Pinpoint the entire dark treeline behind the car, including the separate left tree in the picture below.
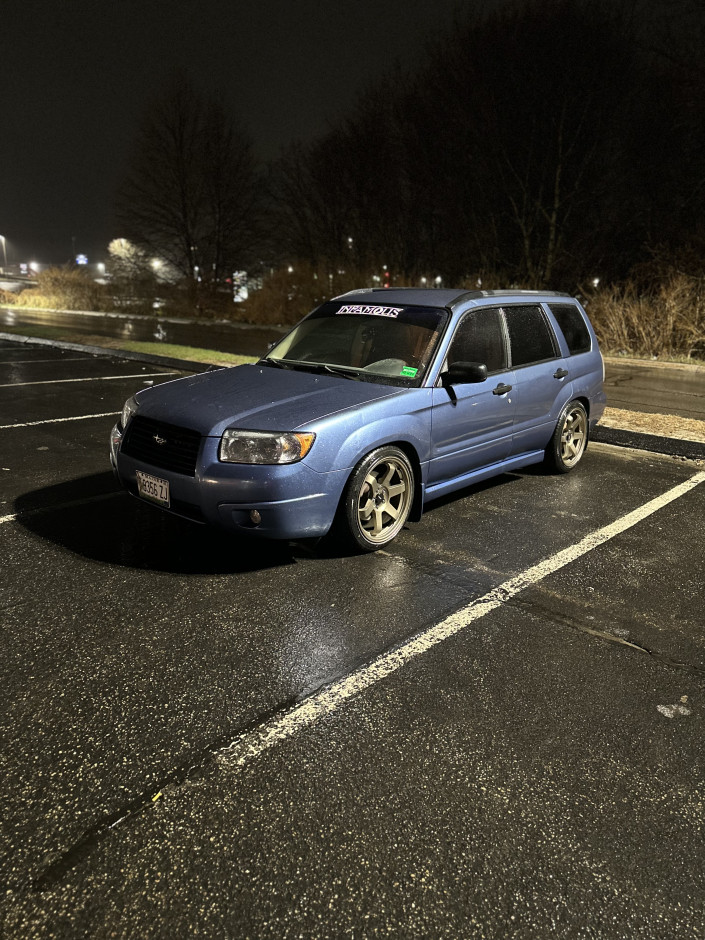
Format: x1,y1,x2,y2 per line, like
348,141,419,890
119,0,705,300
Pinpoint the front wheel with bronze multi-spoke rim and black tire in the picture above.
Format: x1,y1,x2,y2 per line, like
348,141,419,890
339,447,415,552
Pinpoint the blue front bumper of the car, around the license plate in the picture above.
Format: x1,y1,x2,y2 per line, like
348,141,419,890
110,425,347,539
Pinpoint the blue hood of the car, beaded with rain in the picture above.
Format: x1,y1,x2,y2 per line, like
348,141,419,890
137,365,403,437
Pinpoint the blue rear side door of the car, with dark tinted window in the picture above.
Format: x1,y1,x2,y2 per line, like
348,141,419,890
502,304,571,456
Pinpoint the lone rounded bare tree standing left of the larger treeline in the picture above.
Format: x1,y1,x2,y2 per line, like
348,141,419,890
117,77,257,287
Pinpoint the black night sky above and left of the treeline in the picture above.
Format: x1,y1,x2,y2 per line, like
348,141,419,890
0,0,486,263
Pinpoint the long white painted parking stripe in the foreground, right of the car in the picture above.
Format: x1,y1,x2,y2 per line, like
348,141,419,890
217,472,705,767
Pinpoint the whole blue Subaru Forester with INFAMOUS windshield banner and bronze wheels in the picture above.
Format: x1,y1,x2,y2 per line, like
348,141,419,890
110,288,605,551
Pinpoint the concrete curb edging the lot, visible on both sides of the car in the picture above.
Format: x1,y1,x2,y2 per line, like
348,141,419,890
0,333,705,460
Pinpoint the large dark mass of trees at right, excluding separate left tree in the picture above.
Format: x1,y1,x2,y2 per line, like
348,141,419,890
264,0,705,289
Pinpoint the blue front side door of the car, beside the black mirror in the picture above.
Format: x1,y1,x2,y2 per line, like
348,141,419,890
428,308,515,486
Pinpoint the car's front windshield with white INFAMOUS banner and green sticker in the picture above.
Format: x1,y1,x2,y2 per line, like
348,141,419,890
262,301,448,386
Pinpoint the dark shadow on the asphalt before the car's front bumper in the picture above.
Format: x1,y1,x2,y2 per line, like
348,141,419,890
14,471,297,575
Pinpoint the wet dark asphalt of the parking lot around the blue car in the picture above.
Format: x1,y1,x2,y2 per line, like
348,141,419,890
0,342,705,940
